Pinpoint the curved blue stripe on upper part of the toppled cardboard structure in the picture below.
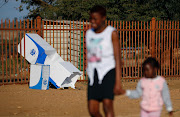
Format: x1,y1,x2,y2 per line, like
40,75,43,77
26,34,47,64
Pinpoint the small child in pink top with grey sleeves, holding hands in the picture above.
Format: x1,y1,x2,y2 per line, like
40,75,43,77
126,57,173,117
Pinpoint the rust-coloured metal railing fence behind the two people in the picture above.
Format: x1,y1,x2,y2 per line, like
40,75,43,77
0,17,180,85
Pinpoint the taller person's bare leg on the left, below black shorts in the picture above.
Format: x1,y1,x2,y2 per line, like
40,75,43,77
88,100,102,117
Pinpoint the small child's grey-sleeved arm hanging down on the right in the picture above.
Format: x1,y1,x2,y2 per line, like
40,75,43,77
162,81,173,113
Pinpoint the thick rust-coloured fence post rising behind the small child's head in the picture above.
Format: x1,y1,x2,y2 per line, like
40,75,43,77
151,17,156,57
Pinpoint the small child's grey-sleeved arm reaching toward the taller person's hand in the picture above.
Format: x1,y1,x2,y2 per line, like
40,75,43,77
126,80,142,99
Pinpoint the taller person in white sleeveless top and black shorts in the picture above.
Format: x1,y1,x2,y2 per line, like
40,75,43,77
86,6,123,117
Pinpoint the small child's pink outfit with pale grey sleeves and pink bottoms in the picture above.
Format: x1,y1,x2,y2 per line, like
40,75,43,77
126,76,172,117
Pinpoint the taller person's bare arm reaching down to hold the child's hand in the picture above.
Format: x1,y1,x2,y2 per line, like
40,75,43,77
112,31,125,95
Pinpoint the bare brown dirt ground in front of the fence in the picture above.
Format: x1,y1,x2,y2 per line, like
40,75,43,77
0,80,180,117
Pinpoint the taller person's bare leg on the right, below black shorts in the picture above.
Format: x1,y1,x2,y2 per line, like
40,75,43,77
103,99,114,117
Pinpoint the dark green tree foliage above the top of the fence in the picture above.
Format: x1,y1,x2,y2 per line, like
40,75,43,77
16,0,180,21
